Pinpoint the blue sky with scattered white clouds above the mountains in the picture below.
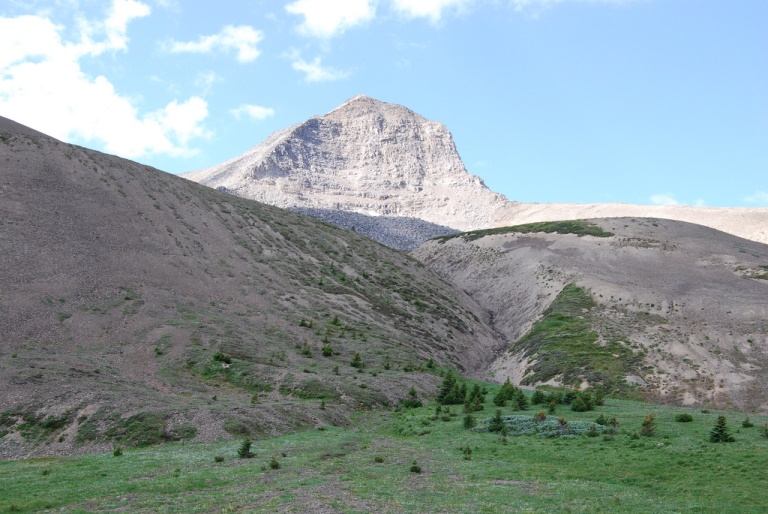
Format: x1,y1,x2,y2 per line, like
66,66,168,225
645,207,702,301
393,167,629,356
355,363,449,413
0,0,768,207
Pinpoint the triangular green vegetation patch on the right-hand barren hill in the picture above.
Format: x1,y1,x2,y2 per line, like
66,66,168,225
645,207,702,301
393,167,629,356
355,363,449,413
510,284,642,397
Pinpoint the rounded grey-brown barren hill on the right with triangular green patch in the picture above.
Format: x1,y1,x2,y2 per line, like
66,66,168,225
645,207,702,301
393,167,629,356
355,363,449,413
413,218,768,409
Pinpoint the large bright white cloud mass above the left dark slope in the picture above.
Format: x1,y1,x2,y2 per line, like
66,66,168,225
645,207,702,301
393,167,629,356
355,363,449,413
0,0,208,158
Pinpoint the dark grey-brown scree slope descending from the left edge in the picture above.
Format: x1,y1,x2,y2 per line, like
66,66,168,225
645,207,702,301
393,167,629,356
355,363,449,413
0,118,495,458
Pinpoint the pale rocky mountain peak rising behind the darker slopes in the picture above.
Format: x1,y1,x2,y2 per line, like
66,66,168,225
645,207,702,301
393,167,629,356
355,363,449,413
184,95,508,230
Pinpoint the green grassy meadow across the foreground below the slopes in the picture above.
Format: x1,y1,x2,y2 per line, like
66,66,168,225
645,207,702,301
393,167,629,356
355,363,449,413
0,385,768,513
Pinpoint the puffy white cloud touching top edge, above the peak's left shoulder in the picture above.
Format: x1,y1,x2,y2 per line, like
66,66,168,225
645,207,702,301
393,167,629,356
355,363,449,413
285,0,377,38
